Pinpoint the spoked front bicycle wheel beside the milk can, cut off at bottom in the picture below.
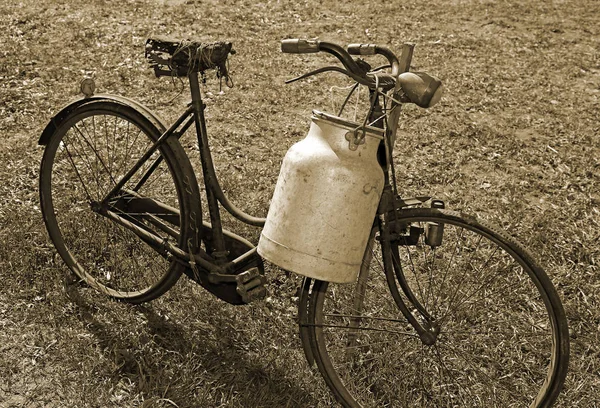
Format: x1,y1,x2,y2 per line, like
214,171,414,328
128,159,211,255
308,209,569,407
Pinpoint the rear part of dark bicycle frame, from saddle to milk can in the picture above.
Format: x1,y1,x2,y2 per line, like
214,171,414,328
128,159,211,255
93,73,265,283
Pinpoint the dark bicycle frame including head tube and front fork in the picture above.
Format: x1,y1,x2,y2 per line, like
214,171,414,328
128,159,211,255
86,44,440,332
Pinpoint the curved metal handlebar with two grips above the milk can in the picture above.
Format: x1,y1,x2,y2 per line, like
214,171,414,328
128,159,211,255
281,38,400,87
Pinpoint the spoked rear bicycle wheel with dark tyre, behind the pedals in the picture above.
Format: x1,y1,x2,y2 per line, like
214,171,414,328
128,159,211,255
40,100,201,303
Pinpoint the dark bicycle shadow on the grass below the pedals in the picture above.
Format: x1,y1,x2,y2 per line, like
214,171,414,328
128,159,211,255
68,284,318,408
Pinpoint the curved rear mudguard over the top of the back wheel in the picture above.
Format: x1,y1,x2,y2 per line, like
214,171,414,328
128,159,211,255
38,94,166,146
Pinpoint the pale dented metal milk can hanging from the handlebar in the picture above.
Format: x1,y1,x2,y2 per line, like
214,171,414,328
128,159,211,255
257,111,384,283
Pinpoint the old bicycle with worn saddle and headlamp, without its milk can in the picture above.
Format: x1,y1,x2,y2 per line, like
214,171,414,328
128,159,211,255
39,38,569,407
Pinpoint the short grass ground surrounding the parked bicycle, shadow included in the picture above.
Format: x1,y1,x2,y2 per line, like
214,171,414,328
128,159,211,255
0,0,600,407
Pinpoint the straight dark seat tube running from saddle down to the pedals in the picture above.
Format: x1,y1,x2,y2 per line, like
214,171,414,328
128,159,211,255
188,72,227,264
